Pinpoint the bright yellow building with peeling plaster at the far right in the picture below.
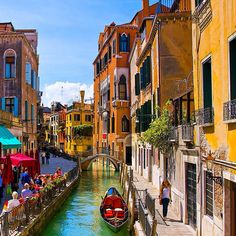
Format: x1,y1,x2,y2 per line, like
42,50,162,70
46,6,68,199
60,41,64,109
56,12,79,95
192,0,236,236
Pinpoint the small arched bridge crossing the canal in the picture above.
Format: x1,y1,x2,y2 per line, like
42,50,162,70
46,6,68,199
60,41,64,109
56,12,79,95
81,153,121,171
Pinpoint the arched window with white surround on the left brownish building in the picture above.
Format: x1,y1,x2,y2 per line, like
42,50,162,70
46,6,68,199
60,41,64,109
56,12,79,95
4,49,16,79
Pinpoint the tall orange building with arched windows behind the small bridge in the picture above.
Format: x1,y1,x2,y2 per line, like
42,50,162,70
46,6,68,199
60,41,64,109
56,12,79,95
93,0,157,164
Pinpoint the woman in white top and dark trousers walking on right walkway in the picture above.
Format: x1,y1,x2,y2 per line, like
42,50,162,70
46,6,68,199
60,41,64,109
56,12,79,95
159,179,171,220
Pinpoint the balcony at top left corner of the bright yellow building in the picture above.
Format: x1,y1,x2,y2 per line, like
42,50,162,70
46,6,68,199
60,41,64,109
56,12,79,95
192,0,212,32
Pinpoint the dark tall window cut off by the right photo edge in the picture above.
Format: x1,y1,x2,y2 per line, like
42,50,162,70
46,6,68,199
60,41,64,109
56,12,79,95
229,38,236,101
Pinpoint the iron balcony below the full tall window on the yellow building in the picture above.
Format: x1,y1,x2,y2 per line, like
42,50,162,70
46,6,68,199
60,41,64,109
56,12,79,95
195,107,214,126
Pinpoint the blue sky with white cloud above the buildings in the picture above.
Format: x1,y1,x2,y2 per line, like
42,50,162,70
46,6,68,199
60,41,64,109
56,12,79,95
0,0,157,106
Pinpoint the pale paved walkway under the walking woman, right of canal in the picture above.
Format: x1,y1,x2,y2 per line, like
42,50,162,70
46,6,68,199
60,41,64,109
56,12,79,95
134,172,195,236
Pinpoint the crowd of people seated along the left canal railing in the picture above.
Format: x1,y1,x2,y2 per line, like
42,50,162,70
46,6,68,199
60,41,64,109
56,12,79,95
0,167,63,212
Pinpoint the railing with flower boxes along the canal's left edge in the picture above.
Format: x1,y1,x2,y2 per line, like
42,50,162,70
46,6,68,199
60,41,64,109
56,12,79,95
0,167,78,236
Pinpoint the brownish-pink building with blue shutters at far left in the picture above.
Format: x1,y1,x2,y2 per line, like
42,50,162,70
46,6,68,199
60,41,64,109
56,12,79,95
0,23,41,152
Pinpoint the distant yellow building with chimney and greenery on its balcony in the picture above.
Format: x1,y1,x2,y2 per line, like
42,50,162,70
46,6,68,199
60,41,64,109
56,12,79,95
65,91,93,156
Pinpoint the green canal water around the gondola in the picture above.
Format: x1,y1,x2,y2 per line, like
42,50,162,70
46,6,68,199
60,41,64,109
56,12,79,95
41,162,130,236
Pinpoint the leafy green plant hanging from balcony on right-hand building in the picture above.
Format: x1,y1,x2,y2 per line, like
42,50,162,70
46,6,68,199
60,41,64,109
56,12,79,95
141,103,172,154
